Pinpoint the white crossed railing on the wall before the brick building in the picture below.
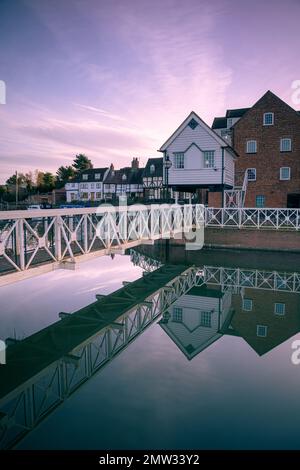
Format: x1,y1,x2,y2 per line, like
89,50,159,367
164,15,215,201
205,207,300,230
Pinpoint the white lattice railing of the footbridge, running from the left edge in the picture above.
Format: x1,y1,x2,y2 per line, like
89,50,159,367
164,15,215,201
0,204,204,274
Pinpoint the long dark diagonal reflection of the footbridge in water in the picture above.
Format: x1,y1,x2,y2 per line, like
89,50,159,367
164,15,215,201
0,266,201,448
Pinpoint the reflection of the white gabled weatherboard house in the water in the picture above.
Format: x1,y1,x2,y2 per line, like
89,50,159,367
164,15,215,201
160,285,232,359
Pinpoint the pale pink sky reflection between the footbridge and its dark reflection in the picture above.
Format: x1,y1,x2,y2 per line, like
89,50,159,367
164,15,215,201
0,256,142,339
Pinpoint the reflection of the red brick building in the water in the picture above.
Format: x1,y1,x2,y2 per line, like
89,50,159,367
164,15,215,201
231,288,300,356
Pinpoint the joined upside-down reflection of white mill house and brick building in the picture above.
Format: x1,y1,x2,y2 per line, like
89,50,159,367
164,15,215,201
160,284,300,359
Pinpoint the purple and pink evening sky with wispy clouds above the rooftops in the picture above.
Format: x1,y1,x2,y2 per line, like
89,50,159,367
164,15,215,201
0,0,300,184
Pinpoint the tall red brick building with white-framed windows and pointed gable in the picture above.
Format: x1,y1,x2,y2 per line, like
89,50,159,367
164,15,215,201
231,91,300,207
